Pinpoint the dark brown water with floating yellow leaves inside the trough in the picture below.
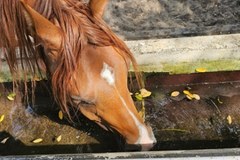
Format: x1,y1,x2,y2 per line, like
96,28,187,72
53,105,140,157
0,72,240,155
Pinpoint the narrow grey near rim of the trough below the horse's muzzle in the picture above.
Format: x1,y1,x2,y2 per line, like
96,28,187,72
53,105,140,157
0,148,240,160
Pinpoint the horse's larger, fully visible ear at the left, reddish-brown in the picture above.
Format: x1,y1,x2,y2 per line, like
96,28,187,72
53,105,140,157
21,0,62,50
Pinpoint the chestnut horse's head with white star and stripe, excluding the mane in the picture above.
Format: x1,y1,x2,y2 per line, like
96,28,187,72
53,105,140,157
21,0,156,150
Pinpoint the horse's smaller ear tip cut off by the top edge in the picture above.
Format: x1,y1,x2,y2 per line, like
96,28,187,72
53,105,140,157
89,0,108,17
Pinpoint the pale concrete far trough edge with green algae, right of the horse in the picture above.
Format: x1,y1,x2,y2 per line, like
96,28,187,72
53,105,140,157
126,34,240,73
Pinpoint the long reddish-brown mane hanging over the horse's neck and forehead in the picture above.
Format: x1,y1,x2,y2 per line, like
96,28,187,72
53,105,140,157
0,0,143,119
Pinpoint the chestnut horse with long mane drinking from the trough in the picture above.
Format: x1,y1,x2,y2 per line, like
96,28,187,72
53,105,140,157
0,0,156,150
